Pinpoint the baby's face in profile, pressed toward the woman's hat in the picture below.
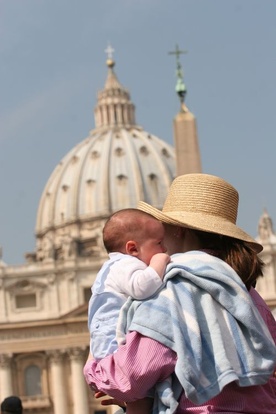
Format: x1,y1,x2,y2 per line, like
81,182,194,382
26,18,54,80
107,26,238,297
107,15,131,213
138,220,167,265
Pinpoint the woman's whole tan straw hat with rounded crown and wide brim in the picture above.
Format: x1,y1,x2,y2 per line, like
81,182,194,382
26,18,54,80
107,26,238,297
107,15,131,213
138,174,263,253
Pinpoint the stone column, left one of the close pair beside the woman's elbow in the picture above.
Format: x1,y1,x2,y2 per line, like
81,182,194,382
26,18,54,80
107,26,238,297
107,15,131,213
48,351,68,414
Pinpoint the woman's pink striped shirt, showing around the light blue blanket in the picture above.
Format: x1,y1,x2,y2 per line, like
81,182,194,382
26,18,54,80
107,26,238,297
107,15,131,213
84,289,276,414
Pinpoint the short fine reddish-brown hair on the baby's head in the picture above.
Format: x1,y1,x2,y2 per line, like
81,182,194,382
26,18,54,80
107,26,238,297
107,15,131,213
103,208,156,253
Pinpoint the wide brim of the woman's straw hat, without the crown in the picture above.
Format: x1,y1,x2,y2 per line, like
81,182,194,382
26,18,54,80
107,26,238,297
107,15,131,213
137,201,263,253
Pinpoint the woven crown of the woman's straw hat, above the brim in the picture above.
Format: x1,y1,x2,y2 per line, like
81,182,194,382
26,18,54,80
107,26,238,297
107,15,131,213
162,174,239,224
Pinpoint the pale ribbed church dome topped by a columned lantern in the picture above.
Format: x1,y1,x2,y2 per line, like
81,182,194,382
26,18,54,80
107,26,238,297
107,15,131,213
36,58,176,262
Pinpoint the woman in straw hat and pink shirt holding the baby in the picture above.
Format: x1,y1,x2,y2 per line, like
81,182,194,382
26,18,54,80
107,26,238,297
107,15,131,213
84,174,276,414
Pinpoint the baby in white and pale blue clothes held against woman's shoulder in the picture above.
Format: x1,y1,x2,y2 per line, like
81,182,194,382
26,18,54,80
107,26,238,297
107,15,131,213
88,209,170,414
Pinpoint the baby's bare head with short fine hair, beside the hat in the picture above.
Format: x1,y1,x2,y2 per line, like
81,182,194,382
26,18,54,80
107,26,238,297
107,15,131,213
103,208,166,264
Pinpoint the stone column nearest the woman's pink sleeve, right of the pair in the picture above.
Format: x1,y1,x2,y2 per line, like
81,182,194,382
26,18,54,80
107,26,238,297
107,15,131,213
69,348,89,414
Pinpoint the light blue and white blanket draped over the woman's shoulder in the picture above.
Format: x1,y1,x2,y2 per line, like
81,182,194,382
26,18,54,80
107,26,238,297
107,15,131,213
118,251,276,413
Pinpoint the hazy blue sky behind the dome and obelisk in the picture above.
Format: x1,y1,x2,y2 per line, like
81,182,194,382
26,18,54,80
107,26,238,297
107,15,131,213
0,0,276,264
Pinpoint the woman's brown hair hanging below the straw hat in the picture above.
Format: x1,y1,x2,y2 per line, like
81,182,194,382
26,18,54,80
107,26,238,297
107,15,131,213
191,230,264,290
